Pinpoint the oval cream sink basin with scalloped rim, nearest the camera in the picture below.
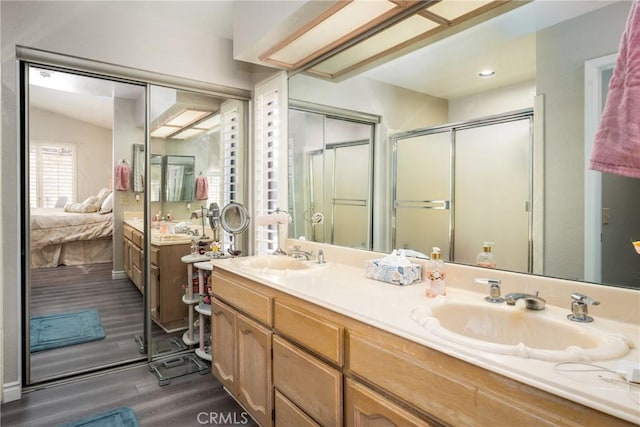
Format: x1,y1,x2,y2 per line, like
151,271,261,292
412,299,632,361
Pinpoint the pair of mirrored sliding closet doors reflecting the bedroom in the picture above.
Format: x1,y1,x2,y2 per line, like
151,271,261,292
22,63,246,385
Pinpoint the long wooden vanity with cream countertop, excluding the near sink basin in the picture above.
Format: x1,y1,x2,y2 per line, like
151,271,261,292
211,241,640,426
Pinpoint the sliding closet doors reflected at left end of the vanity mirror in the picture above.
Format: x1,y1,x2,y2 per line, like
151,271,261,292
289,105,378,249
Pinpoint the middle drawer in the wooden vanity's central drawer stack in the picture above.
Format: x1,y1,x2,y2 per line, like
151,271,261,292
273,336,342,426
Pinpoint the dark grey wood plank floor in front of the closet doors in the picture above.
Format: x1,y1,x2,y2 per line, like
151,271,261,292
0,365,257,427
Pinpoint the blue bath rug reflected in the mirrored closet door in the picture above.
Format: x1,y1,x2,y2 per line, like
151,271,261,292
30,309,105,353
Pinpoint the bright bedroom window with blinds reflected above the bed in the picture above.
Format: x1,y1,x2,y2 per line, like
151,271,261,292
29,141,76,208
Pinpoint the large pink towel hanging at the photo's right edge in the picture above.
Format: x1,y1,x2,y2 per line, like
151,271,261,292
590,0,640,178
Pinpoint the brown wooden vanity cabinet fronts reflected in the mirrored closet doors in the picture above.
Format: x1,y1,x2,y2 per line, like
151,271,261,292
123,223,190,331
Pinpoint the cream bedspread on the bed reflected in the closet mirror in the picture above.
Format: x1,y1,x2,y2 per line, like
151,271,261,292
31,208,113,250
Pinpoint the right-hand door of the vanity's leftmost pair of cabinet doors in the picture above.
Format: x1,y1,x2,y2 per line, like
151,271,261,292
236,314,273,427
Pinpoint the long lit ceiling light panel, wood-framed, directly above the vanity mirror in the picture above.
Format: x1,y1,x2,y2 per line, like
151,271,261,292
267,0,397,66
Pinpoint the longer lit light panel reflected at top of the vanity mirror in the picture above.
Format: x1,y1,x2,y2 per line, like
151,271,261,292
309,15,438,75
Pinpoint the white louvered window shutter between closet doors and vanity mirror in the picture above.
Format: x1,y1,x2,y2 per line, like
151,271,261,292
253,76,287,253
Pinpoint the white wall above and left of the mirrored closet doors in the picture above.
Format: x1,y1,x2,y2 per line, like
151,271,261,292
0,0,252,400
